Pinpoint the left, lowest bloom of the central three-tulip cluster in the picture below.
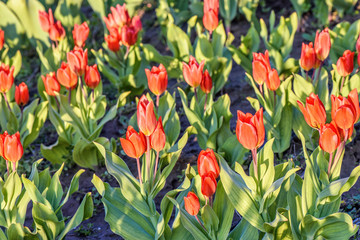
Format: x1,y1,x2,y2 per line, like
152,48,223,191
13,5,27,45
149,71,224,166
120,126,146,158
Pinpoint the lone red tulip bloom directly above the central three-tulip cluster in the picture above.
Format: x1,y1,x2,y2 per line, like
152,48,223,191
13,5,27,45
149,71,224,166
145,64,168,96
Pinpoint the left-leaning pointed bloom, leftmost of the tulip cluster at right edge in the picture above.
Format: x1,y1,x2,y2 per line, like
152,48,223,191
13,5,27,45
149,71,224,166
297,93,326,129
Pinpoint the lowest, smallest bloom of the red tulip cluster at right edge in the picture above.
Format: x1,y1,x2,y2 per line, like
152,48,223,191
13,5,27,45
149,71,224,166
319,123,341,153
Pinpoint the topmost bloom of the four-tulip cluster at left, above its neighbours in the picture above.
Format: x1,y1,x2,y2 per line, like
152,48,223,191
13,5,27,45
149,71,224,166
67,48,88,76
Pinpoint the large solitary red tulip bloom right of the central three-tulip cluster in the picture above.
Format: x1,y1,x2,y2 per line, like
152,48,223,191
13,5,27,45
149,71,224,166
236,108,265,150
